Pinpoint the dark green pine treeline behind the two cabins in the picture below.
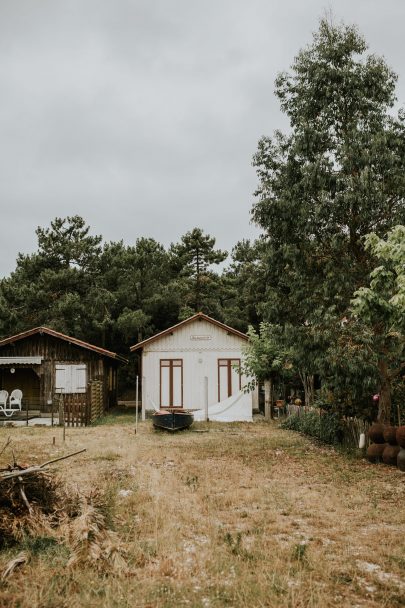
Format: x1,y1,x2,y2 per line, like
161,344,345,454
0,216,257,354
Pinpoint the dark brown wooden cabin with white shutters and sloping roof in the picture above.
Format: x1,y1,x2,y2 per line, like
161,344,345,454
0,327,127,422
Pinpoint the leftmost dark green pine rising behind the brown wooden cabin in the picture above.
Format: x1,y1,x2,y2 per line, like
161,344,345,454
0,216,102,338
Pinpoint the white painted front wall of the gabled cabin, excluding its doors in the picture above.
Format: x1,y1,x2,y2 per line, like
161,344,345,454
142,319,253,419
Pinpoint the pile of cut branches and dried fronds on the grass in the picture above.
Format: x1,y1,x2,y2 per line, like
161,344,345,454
0,443,126,578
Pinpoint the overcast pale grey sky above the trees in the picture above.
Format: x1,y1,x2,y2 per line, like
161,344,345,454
0,0,405,277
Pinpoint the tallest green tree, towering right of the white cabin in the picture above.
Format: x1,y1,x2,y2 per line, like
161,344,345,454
252,20,405,410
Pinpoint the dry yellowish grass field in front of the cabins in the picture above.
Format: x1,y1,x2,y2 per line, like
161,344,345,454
0,416,405,608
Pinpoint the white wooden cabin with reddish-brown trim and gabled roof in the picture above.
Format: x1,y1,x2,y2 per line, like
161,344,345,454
131,313,257,422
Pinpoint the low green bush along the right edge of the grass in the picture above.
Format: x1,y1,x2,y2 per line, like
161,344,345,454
281,411,343,445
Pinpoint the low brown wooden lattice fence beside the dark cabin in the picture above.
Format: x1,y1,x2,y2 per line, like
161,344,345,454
56,380,104,427
